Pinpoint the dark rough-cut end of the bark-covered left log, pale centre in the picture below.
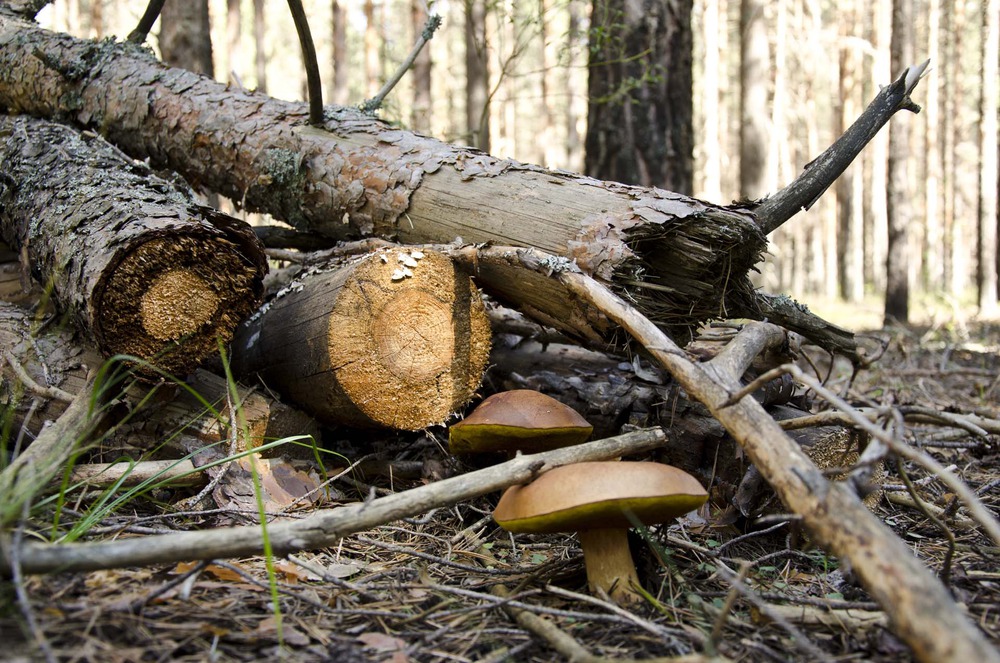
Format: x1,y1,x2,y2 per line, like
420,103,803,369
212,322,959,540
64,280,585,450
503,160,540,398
94,235,262,375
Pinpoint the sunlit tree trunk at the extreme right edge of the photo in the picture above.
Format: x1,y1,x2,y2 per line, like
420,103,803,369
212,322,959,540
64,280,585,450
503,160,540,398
976,0,1000,315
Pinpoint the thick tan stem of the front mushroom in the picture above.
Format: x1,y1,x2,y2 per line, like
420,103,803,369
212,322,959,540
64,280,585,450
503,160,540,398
578,527,643,605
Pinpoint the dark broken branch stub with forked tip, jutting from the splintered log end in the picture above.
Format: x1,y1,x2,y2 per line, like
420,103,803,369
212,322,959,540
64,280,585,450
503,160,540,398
754,60,930,234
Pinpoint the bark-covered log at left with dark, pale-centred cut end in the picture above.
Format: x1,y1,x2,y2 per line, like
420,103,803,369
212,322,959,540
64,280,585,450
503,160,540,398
0,116,267,376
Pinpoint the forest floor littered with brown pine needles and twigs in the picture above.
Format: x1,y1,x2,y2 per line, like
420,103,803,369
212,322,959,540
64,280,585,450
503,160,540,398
0,316,1000,663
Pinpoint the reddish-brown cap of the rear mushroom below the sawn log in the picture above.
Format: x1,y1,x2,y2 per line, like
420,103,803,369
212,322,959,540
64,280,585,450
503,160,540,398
448,389,594,453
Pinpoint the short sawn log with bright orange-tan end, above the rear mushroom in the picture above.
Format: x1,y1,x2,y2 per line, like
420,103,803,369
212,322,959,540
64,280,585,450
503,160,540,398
233,248,490,430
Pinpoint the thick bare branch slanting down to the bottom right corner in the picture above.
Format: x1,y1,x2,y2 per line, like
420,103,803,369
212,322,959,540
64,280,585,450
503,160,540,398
556,267,1000,663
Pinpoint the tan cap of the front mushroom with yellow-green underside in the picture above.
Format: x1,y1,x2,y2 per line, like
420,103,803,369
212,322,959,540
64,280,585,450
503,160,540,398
493,461,708,534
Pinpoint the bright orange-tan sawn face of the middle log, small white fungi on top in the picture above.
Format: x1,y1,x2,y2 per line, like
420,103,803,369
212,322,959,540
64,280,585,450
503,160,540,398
329,251,490,430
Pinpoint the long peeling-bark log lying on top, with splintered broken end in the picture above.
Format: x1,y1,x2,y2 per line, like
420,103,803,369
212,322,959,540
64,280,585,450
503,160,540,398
0,16,923,359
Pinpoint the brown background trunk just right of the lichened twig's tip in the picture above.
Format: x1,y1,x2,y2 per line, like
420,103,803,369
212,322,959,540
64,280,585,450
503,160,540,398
465,0,490,152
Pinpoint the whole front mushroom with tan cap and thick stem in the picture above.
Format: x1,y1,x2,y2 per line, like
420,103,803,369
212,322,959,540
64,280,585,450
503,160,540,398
493,461,708,604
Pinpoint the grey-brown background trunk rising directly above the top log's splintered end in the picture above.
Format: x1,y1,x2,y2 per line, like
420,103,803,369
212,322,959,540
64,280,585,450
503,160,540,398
740,0,770,200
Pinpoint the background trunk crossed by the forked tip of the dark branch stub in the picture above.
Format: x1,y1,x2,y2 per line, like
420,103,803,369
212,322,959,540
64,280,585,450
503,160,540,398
885,0,913,324
